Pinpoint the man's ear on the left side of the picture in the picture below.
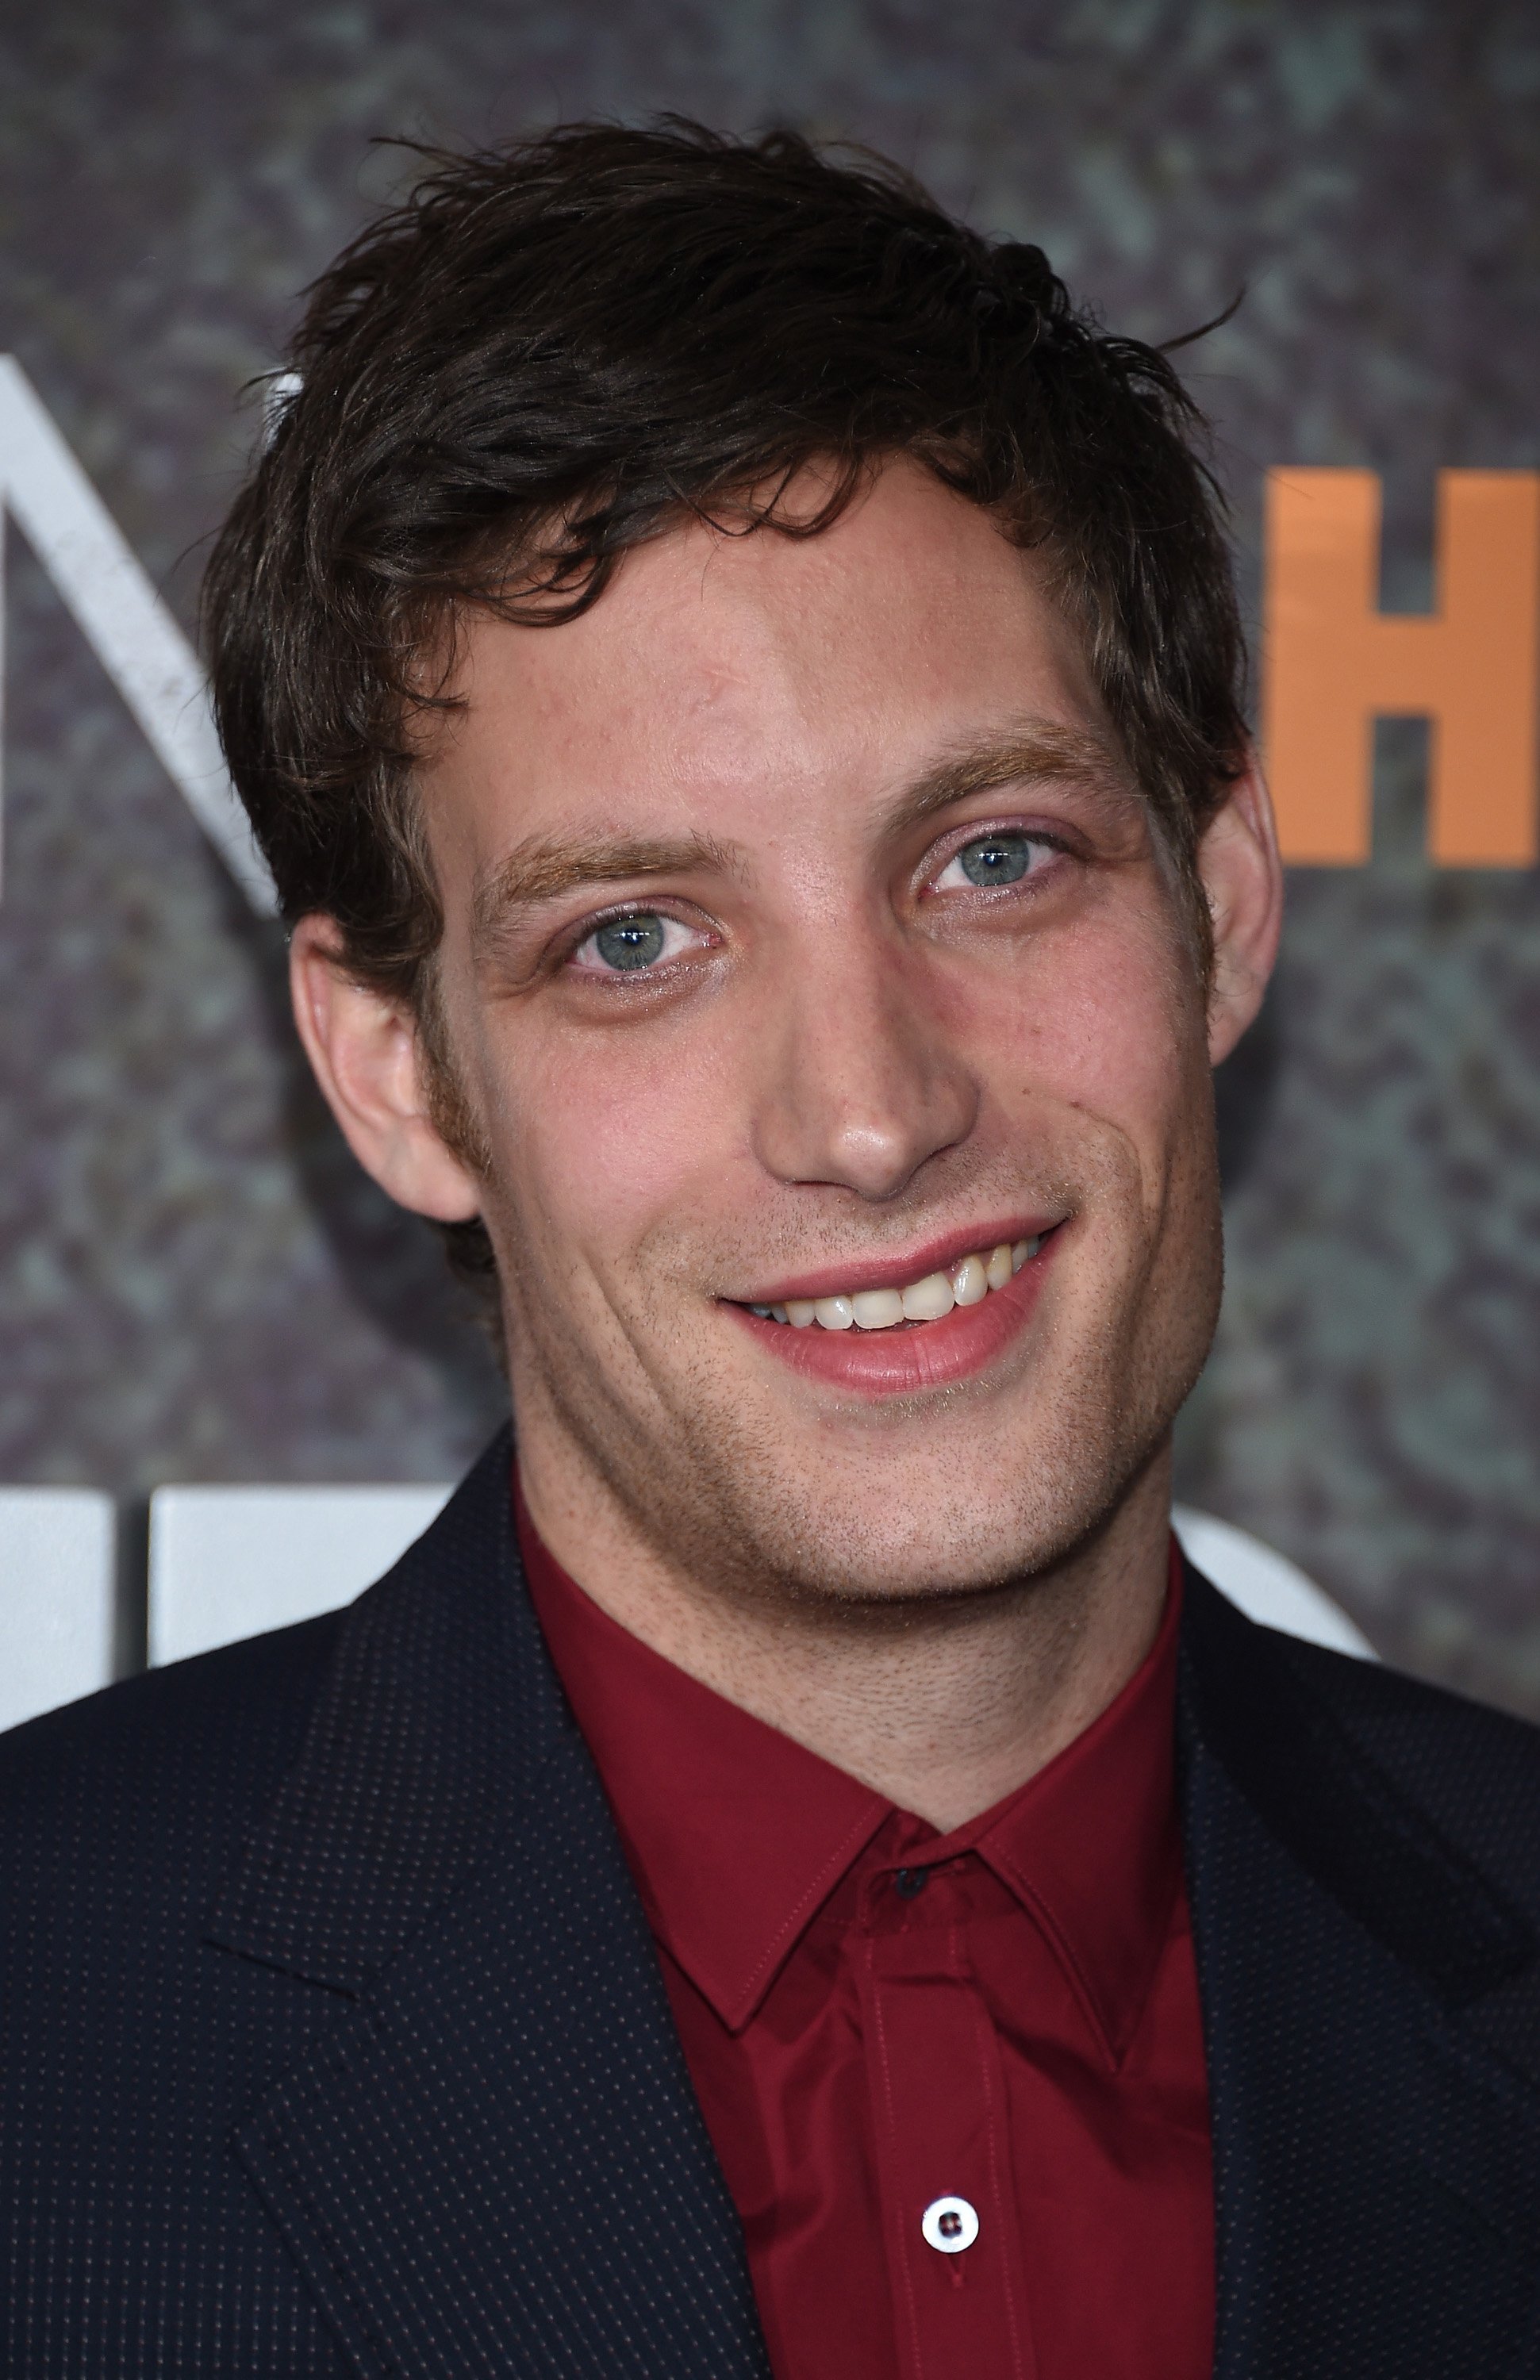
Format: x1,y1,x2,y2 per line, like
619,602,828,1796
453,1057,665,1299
288,916,481,1223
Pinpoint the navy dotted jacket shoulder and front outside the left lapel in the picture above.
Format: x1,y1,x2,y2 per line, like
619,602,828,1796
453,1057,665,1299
0,1618,345,2380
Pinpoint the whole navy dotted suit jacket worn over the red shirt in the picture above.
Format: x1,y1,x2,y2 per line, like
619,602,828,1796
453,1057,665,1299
0,1440,1540,2380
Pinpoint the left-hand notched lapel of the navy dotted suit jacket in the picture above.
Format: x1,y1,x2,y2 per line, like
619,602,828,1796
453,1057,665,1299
214,1440,766,2380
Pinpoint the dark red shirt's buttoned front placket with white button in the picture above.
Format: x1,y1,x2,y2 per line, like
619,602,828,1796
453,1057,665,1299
859,1868,1038,2380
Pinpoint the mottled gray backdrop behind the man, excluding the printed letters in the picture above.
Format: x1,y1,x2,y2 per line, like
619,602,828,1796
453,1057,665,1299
0,0,1540,1716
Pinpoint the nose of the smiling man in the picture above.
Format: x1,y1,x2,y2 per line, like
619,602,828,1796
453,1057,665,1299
755,933,978,1204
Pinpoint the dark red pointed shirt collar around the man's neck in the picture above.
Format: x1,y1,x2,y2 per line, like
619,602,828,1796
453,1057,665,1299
517,1495,1181,2063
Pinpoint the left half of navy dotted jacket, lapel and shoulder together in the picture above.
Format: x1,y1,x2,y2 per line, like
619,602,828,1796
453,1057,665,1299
0,1435,769,2380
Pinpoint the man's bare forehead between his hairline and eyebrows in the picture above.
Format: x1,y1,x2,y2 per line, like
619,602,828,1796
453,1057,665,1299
428,464,1114,864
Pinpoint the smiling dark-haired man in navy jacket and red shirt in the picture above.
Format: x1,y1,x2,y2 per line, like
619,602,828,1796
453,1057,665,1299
2,126,1540,2380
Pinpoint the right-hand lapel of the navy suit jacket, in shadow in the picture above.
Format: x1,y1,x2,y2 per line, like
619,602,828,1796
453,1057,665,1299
1181,1573,1540,2380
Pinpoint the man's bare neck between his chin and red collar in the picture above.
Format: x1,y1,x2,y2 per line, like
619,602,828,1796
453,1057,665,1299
524,1442,1171,1833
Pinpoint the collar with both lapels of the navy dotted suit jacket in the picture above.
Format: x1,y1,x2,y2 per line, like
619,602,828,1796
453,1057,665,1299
212,1435,1540,2380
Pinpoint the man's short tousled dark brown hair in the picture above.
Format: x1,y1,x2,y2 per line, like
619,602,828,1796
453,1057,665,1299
205,119,1247,1264
